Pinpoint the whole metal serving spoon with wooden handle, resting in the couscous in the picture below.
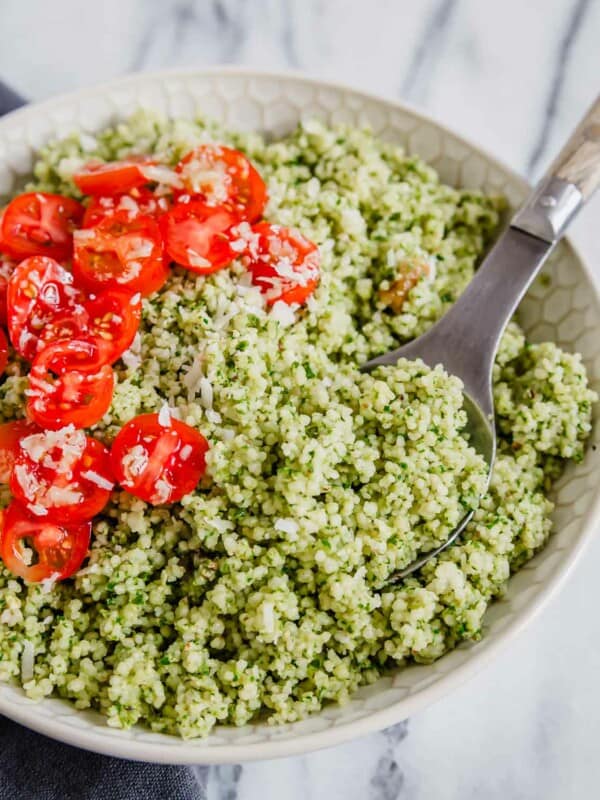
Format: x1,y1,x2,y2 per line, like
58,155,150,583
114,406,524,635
361,96,600,582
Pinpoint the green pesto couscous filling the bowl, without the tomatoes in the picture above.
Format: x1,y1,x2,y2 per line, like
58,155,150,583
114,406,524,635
0,112,595,738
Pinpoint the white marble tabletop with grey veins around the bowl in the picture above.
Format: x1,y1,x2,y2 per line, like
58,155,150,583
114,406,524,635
0,0,600,800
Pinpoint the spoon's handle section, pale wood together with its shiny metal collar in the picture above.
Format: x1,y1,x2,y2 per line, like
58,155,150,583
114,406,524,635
511,97,600,243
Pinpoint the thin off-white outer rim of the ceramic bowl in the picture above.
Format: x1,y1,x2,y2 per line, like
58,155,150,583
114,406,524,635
0,65,600,765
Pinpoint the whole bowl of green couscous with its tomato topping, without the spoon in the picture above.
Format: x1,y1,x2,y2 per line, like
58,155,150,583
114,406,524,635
0,69,600,763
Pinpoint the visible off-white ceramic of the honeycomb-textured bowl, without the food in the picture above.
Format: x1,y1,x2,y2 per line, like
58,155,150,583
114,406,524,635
0,68,600,764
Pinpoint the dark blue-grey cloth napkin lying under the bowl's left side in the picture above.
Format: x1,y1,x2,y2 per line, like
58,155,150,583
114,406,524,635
0,81,208,800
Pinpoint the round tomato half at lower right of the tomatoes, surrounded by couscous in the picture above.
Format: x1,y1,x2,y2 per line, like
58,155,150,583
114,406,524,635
111,412,208,505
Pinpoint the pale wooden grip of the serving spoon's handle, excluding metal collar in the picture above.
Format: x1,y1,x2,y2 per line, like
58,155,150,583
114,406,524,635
550,97,600,200
